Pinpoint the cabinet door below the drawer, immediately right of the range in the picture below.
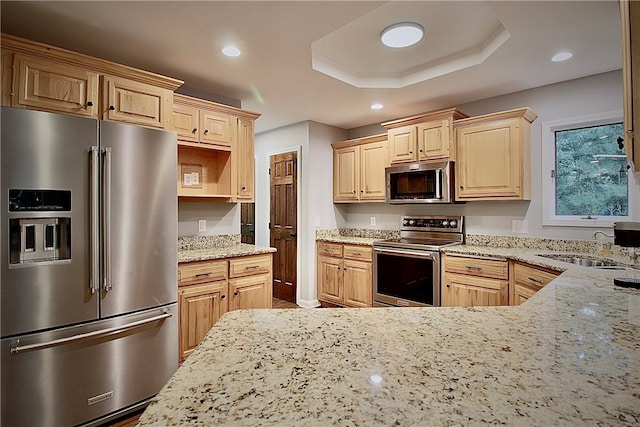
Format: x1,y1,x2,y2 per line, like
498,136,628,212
442,273,509,307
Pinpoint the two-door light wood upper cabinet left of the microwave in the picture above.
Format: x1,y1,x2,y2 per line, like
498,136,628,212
331,134,387,203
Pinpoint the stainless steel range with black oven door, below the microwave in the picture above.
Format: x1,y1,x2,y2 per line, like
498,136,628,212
373,216,464,307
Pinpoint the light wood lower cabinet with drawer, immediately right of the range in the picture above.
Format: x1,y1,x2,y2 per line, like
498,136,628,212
441,254,509,307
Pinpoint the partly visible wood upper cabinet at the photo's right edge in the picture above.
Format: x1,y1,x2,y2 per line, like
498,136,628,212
620,0,640,172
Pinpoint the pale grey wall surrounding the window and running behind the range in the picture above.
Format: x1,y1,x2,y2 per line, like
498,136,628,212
341,71,640,240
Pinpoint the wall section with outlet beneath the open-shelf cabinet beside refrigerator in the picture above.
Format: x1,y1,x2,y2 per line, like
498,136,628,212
178,202,240,237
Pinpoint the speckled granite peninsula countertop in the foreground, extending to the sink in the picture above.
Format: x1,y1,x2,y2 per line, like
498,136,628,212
140,242,640,426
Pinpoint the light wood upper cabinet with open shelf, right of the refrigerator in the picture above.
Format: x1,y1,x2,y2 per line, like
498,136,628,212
172,94,260,202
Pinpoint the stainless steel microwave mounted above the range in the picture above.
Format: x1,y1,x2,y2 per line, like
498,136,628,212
385,162,454,204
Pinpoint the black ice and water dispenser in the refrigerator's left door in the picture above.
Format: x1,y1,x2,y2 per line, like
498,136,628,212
9,189,71,266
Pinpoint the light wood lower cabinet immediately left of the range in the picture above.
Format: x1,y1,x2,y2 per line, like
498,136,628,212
317,242,373,307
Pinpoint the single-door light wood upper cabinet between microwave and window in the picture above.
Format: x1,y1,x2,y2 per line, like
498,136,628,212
455,107,537,201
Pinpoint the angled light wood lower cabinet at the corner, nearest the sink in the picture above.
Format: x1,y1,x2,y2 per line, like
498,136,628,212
509,261,560,305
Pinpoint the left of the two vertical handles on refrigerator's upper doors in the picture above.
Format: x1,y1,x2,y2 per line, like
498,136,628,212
87,145,100,294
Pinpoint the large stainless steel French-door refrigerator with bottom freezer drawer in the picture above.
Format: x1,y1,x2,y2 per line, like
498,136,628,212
0,107,178,426
